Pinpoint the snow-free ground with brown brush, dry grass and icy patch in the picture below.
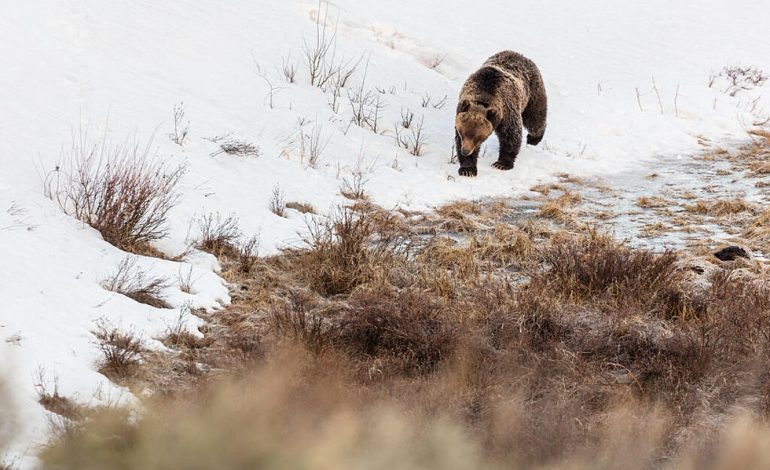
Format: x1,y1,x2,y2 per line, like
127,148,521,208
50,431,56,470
25,132,770,468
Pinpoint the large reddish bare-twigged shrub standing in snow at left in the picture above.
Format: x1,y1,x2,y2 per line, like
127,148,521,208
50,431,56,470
45,133,185,252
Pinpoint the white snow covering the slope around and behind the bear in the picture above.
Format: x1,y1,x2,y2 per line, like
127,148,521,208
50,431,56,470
0,0,770,467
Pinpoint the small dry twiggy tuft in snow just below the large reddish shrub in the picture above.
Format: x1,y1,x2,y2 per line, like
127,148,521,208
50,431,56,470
102,256,171,308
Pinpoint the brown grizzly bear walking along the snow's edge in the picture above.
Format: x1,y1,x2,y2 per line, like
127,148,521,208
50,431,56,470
455,51,548,176
